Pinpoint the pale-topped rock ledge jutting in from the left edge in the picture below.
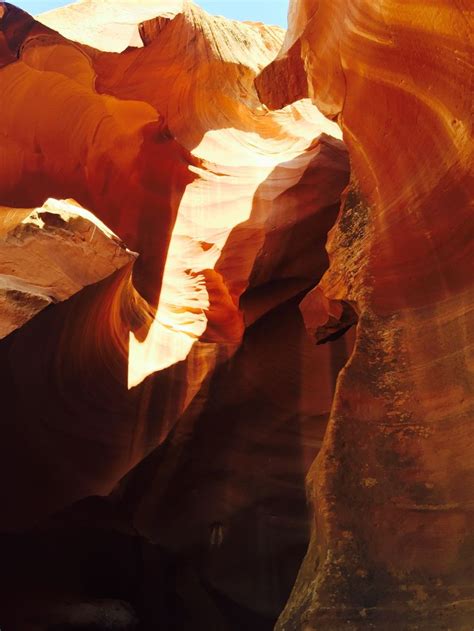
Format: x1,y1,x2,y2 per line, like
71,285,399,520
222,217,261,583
0,199,135,338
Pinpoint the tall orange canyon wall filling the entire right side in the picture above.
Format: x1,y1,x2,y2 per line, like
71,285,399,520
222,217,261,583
257,0,474,631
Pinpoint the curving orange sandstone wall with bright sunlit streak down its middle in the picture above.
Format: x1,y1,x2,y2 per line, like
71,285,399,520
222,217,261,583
0,2,348,568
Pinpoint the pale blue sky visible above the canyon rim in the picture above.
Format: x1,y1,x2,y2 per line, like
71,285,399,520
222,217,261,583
18,0,288,27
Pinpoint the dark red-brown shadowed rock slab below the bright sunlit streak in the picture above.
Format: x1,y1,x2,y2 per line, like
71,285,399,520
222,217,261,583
107,299,353,629
